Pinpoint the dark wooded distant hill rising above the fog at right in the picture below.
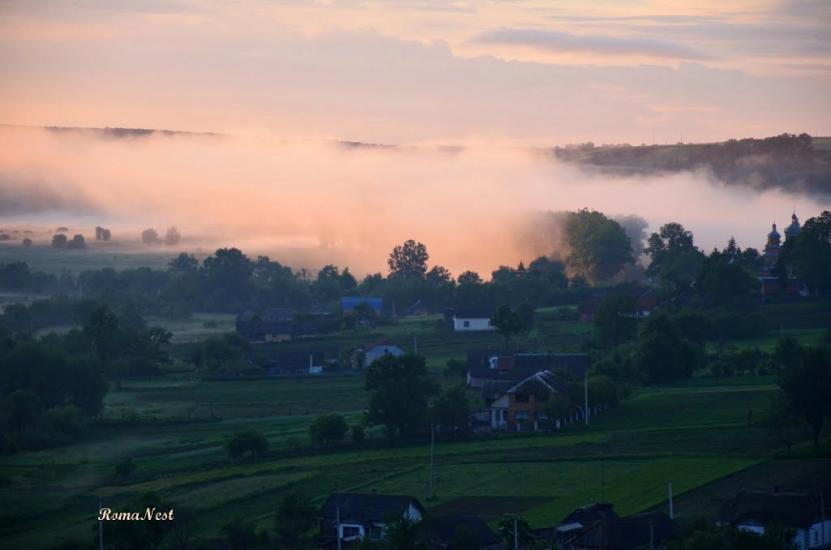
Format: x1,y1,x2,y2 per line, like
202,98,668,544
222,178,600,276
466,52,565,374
550,134,831,198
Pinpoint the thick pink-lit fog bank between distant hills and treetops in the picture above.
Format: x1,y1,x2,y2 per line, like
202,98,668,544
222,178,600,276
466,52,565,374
0,127,821,274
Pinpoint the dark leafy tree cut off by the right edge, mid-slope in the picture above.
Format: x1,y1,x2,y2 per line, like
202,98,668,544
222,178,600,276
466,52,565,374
779,347,831,445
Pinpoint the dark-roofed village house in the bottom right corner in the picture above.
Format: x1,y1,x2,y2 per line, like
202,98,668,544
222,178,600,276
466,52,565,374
716,489,831,550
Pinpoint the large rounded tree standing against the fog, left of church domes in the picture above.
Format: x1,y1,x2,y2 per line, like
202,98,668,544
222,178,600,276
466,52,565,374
565,209,634,281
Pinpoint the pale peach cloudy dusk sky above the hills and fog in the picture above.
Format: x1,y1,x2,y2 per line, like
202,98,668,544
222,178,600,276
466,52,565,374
0,0,831,145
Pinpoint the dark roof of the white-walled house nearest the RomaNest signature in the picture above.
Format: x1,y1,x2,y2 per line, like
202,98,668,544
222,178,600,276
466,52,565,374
320,493,424,523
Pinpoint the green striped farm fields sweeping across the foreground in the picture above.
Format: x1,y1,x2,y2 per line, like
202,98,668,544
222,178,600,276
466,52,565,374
0,377,788,547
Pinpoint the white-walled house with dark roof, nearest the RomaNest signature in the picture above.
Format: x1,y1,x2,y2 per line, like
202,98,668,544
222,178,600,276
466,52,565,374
320,493,425,548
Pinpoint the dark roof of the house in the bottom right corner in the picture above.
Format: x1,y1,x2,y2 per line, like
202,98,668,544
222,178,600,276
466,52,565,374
716,491,820,527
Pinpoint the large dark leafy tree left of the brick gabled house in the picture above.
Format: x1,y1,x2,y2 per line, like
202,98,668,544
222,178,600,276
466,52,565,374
365,354,437,439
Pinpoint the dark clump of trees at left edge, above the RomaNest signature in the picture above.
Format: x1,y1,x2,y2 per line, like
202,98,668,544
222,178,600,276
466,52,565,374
0,306,170,451
